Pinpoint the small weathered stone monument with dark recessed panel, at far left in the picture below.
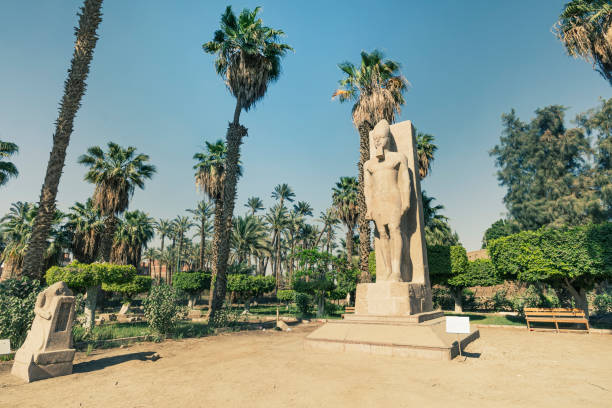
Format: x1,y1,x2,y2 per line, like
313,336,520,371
11,282,75,382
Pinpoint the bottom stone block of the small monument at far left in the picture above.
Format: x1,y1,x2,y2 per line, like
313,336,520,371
11,349,75,382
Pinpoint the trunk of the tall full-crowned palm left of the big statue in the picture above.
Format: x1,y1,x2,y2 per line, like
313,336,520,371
209,98,247,321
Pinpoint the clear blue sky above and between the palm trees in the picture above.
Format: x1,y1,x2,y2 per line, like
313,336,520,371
0,0,612,250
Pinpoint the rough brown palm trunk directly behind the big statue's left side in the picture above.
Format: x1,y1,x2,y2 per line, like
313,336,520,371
356,122,372,283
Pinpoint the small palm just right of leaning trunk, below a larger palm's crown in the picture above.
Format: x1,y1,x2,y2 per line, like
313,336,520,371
66,198,104,263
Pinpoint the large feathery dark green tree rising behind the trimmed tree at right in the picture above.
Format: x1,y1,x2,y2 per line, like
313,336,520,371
490,105,603,230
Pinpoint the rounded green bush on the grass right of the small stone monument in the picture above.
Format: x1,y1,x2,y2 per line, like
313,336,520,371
142,285,183,336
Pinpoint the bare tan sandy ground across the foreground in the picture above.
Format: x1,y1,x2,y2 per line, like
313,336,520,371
0,324,612,408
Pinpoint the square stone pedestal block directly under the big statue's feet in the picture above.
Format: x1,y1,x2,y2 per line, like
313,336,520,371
355,282,432,316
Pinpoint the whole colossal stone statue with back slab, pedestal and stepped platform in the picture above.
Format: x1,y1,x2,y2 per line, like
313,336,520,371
305,120,479,359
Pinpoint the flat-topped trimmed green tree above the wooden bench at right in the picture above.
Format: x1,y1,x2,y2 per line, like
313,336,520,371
488,223,612,315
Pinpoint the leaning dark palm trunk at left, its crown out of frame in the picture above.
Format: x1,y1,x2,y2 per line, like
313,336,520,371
23,0,102,278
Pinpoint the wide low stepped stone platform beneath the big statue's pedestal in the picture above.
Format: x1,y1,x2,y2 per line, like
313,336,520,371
304,312,480,360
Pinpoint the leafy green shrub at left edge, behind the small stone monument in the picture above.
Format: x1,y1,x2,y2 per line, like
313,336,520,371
0,277,41,350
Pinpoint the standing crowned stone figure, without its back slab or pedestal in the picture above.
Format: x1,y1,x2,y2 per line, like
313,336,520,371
363,120,413,282
